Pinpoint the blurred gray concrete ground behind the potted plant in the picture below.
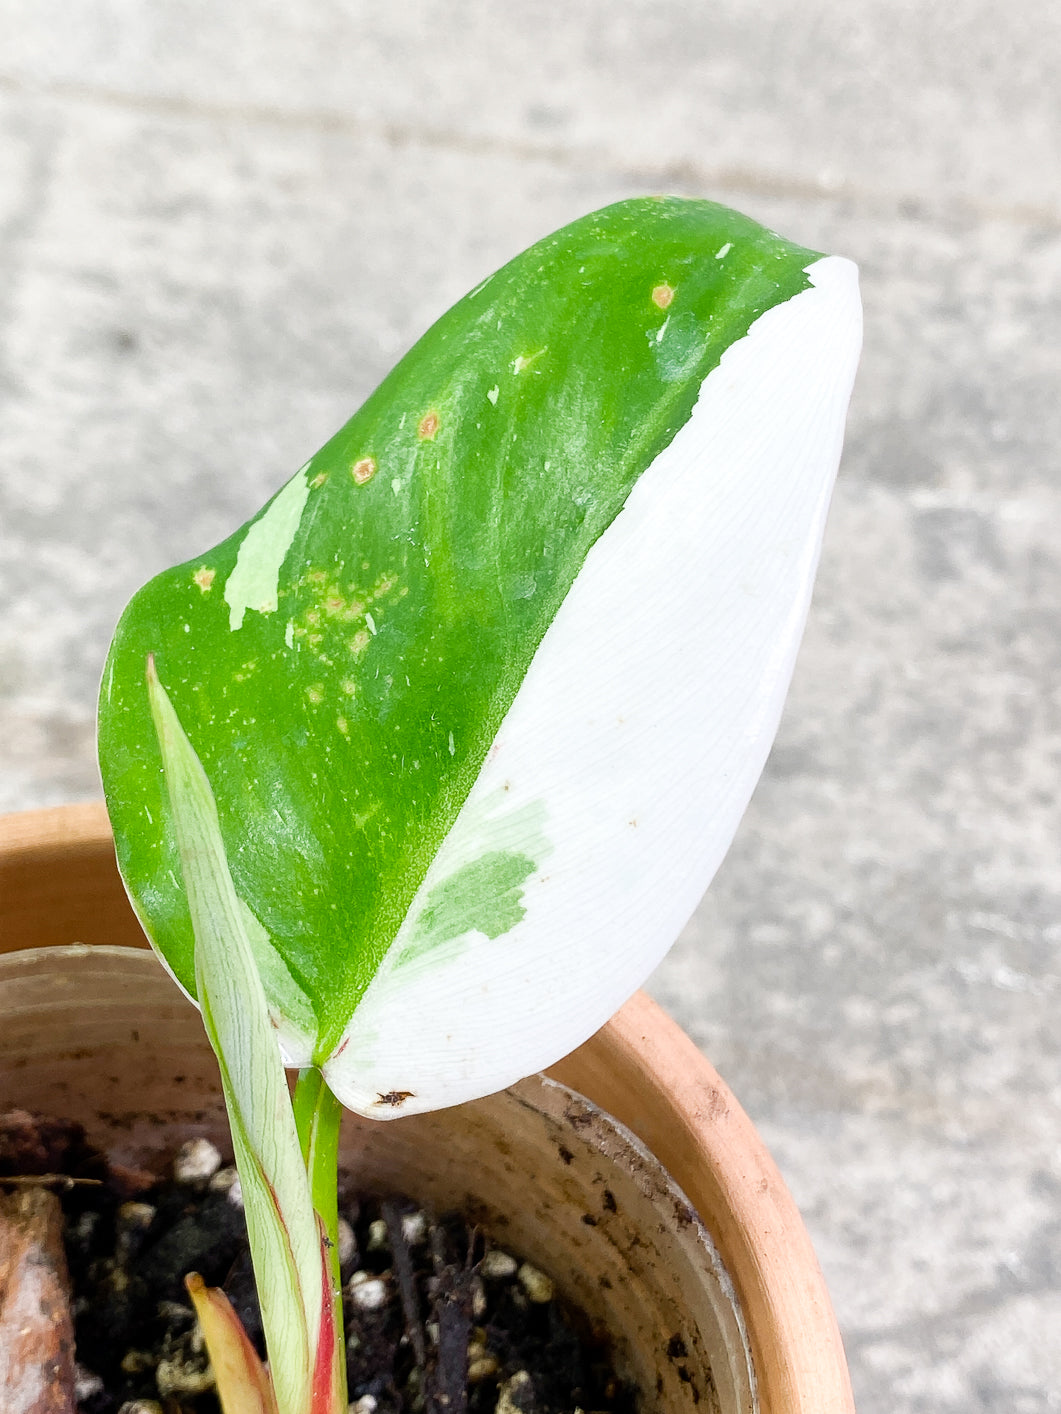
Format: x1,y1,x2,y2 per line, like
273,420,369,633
0,0,1061,1414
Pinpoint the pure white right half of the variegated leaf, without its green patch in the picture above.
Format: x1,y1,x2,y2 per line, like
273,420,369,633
325,257,862,1117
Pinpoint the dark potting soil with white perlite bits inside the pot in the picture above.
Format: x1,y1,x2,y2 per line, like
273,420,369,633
0,1111,637,1414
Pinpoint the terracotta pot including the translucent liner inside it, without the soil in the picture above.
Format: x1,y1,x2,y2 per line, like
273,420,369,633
0,805,853,1414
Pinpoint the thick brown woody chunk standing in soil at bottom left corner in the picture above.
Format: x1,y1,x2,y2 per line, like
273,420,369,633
0,1188,75,1414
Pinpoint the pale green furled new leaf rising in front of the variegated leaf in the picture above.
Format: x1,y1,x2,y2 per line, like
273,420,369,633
147,660,324,1414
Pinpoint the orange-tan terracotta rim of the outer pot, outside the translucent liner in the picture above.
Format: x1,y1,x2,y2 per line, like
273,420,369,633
0,802,854,1414
